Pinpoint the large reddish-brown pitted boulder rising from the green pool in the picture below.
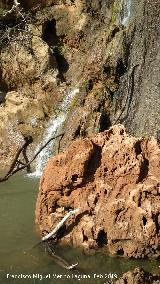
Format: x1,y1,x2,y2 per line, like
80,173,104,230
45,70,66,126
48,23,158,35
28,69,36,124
36,125,160,258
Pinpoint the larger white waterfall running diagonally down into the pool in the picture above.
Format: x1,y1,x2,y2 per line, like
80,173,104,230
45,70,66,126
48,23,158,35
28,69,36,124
29,88,79,177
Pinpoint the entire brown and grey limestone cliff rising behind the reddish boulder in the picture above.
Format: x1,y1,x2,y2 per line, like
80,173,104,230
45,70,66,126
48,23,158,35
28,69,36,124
0,0,160,167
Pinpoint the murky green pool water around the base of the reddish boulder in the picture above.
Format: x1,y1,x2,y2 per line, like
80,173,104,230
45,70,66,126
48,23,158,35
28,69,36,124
0,176,160,284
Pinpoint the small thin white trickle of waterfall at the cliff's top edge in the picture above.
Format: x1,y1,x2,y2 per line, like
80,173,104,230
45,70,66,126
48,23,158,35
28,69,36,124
120,0,131,26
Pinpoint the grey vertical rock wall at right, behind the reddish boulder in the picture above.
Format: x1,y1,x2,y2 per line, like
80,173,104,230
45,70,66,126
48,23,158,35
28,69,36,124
113,0,160,137
